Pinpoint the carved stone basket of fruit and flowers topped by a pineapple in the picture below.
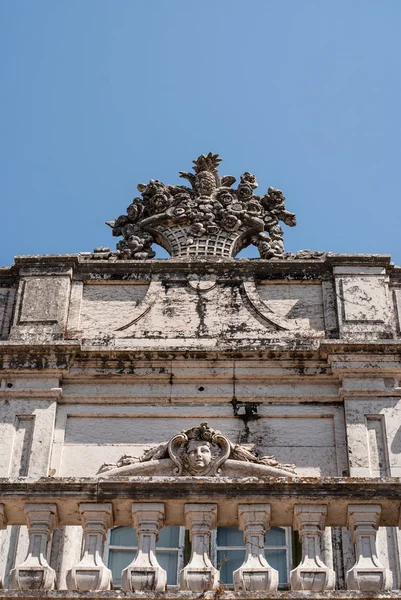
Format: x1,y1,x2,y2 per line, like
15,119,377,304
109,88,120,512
107,152,296,260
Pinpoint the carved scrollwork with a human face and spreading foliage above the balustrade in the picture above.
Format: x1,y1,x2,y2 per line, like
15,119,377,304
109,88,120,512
98,422,295,477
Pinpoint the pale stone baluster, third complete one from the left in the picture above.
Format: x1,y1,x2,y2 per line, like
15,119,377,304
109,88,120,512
122,503,167,592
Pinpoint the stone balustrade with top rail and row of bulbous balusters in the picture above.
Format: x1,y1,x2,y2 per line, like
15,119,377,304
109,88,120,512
0,477,401,595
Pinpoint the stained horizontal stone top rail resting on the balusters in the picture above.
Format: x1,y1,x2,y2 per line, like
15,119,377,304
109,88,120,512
0,472,401,527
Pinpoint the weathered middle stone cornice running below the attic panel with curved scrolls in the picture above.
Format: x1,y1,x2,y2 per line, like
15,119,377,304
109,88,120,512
0,340,401,378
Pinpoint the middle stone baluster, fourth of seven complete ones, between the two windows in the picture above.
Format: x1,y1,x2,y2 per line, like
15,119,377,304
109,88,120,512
180,504,220,592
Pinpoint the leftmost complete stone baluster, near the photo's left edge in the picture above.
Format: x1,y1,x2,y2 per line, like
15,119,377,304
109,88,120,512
10,504,58,590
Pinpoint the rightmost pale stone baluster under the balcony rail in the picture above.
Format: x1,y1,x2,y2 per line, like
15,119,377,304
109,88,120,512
346,504,393,592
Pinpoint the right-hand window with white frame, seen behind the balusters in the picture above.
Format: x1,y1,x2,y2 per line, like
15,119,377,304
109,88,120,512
212,527,291,584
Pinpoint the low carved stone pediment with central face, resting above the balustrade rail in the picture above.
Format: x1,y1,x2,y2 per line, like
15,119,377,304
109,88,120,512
98,422,296,477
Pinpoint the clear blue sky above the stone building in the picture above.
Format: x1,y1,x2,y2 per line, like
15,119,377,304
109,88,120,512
0,0,401,265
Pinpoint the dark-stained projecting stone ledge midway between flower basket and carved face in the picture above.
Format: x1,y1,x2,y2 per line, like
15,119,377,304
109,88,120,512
0,338,401,374
